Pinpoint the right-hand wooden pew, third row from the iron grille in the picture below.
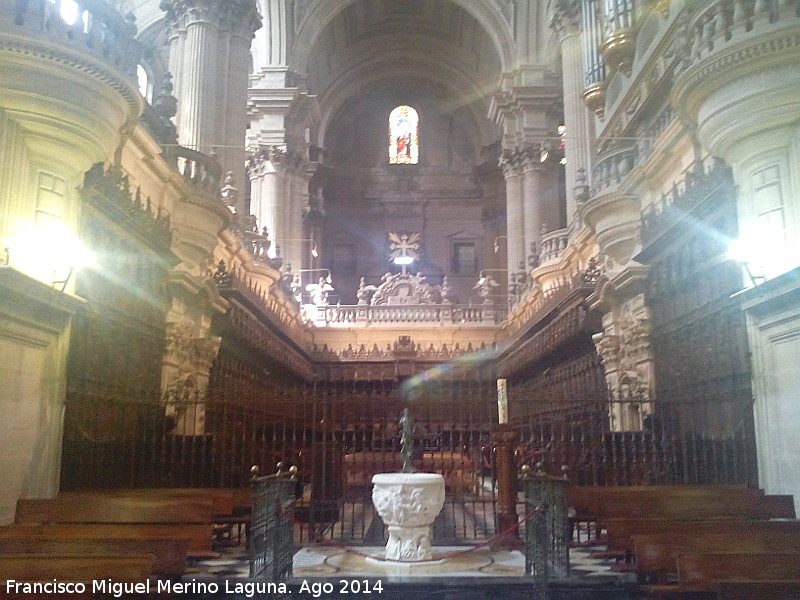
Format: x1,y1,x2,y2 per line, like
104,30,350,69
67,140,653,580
633,528,800,584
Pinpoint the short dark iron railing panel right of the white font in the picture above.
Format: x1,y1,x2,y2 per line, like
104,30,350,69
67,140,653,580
522,465,570,577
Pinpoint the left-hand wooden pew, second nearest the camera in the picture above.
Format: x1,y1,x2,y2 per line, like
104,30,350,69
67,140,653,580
0,532,189,577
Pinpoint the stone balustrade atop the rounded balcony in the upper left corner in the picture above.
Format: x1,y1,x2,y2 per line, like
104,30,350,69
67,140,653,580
0,0,142,81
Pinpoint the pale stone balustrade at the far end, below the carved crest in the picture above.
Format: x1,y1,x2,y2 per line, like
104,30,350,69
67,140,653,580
315,304,506,327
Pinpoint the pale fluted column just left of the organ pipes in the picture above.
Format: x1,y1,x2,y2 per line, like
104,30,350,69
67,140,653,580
550,0,591,224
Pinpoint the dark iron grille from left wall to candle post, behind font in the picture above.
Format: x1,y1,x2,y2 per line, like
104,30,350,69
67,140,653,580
62,372,496,545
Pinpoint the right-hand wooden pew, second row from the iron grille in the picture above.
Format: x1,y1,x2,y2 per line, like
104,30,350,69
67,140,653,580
604,519,800,554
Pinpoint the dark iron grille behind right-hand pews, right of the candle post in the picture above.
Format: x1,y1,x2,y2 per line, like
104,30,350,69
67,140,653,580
518,396,756,485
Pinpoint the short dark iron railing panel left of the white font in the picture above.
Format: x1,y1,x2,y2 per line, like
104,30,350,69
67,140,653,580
250,463,297,581
